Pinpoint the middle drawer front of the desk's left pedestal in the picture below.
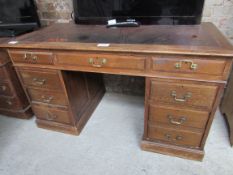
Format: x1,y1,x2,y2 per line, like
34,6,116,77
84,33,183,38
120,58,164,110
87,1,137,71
27,88,67,106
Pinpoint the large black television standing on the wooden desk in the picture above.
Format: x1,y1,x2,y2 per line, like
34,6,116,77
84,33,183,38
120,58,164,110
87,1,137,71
73,0,204,24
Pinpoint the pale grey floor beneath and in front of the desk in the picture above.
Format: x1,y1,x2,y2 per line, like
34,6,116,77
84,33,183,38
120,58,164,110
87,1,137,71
0,93,233,175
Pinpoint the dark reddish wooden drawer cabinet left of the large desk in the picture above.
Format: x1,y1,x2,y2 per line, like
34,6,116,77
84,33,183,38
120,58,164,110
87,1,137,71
0,50,33,119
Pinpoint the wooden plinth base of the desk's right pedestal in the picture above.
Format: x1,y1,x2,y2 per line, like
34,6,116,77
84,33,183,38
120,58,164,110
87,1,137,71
141,139,204,161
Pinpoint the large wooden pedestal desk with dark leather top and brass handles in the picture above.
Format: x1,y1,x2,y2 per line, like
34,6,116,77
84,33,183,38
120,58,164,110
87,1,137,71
1,23,233,160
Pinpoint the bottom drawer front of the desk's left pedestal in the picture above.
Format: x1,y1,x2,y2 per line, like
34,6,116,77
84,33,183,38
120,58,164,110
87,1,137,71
32,105,71,124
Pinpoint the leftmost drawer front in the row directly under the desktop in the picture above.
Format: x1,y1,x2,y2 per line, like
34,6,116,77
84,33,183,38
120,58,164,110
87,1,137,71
9,50,53,65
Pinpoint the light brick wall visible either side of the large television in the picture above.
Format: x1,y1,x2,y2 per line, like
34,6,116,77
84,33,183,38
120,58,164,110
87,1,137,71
35,0,233,43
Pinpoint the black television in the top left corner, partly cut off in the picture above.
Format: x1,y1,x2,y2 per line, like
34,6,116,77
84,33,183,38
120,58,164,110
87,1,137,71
0,0,40,37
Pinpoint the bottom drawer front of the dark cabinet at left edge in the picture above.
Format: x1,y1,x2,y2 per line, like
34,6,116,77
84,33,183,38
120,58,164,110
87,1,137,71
0,97,23,110
